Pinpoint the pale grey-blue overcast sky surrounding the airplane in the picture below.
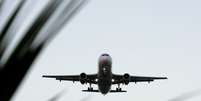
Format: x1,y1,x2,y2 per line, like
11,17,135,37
5,0,201,101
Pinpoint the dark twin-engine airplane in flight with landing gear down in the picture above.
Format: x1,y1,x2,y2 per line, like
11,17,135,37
42,53,167,95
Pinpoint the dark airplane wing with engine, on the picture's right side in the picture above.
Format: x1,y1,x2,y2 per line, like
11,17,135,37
112,73,167,84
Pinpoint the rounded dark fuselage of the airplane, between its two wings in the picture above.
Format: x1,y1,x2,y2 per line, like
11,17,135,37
98,54,112,95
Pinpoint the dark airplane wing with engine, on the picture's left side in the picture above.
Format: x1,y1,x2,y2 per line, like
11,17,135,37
42,73,97,84
